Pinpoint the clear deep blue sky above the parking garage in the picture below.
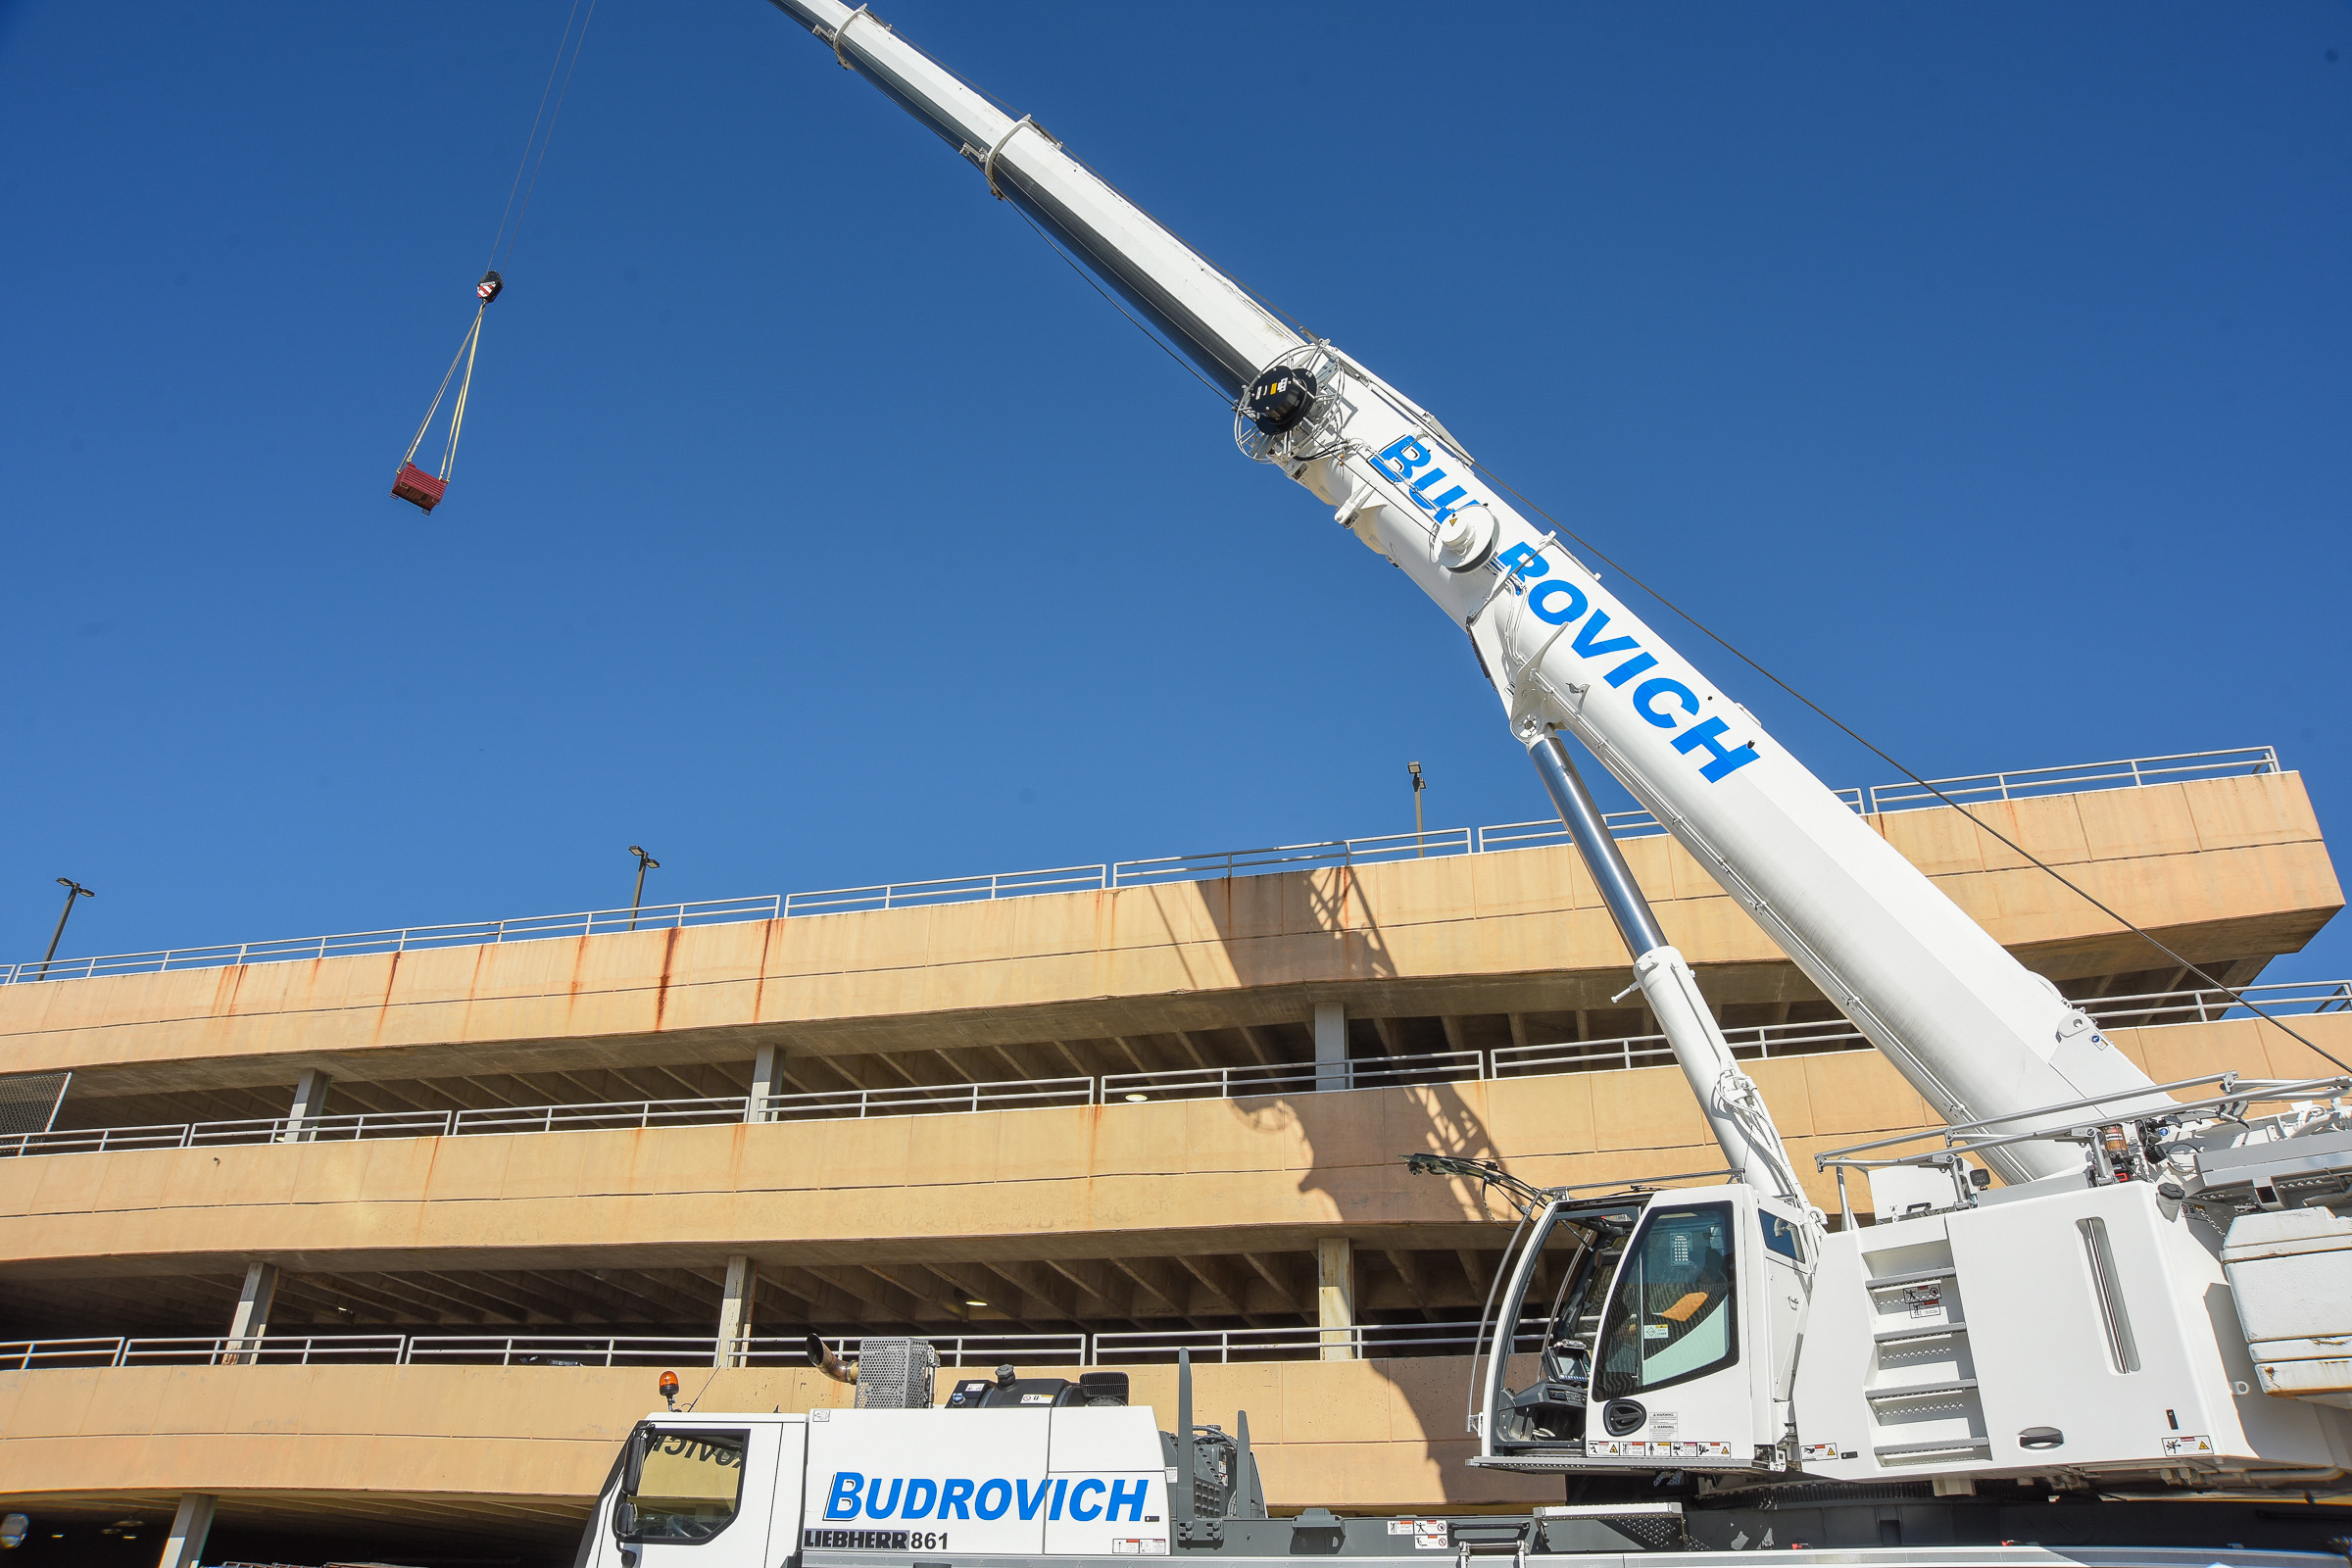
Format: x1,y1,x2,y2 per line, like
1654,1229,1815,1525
0,0,2352,976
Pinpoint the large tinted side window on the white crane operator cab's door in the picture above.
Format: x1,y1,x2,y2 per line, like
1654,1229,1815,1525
1594,1203,1740,1398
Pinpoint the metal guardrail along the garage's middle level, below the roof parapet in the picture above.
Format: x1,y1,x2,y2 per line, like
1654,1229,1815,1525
0,980,2352,1165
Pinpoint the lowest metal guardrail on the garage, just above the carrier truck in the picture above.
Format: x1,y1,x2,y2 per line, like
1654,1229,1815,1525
0,1319,1505,1373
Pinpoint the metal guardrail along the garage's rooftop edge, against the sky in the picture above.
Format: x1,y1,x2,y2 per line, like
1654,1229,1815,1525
0,745,2281,985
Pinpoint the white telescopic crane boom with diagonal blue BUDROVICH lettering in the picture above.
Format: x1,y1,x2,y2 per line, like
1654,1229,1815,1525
771,0,2150,1185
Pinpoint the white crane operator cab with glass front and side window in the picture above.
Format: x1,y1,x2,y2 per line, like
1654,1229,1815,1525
1470,1185,1818,1472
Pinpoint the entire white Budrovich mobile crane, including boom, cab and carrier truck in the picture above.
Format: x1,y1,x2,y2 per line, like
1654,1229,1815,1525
568,0,2352,1568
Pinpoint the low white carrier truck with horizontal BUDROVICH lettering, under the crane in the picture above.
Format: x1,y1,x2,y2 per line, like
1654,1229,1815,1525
574,1405,2342,1568
